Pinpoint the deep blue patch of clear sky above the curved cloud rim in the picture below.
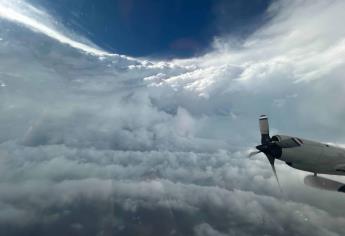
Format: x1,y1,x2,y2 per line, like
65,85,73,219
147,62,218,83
33,0,271,58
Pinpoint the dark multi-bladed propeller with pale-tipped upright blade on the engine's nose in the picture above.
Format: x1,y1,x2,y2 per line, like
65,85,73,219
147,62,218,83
249,115,282,187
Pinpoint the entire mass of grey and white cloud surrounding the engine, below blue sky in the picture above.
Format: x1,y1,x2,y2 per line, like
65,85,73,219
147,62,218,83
0,1,345,236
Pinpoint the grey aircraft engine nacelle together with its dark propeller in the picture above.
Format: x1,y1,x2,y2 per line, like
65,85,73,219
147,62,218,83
249,115,345,184
